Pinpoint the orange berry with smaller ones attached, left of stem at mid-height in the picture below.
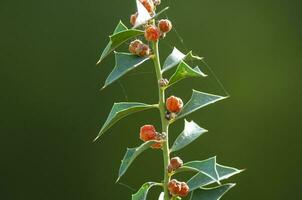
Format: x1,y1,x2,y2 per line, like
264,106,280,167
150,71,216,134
140,125,164,149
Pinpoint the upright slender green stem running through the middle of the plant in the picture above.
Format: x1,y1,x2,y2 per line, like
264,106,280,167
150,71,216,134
152,41,170,200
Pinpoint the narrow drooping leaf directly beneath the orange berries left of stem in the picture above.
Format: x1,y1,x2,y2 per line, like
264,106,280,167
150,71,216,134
117,140,156,181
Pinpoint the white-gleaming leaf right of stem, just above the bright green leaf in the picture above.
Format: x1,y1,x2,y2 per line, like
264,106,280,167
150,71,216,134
162,47,203,73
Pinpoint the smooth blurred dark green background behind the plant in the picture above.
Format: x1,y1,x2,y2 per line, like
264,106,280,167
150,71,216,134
0,0,302,200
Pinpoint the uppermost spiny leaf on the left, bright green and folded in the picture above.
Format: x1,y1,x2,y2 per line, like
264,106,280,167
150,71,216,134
97,21,144,64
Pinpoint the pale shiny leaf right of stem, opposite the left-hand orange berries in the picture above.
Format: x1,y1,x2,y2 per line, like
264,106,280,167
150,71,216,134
170,120,208,152
